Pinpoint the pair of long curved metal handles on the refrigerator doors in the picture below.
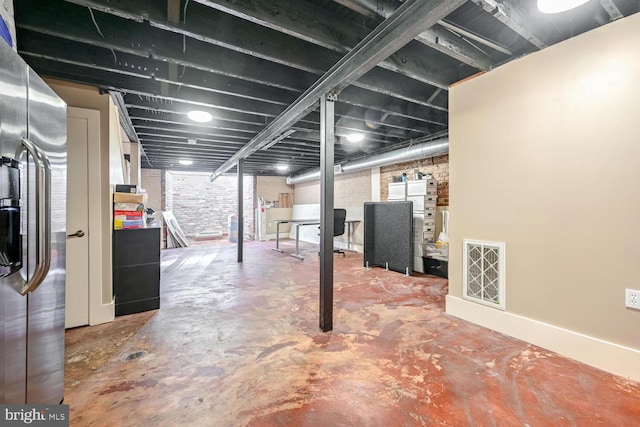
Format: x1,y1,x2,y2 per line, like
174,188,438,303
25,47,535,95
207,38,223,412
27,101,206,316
18,138,51,295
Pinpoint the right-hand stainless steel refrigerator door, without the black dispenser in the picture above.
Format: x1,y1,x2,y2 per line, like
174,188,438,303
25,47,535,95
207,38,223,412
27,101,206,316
26,70,67,404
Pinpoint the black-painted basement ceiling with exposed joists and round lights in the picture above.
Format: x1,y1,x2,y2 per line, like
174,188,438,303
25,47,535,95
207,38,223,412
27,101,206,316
14,0,640,175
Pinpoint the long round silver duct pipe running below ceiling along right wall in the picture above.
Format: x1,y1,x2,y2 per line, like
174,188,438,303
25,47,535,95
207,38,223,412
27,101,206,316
287,138,449,185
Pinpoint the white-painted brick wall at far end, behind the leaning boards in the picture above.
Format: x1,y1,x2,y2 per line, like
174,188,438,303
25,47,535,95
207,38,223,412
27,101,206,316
165,171,255,238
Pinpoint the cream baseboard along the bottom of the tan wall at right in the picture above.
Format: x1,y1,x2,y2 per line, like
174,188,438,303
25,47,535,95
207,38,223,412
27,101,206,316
446,295,640,381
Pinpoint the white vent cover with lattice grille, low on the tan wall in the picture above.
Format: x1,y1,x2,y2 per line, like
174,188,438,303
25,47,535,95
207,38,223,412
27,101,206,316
462,239,505,310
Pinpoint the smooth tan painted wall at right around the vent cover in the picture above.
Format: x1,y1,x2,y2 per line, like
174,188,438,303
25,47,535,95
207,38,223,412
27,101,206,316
449,14,640,352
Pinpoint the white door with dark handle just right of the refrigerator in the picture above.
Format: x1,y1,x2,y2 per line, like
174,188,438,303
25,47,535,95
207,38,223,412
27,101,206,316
65,107,94,328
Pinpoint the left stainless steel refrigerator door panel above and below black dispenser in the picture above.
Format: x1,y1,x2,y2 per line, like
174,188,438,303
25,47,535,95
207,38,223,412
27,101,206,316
0,36,27,404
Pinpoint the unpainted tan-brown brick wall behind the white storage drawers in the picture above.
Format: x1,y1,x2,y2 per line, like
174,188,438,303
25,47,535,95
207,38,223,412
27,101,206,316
380,154,449,206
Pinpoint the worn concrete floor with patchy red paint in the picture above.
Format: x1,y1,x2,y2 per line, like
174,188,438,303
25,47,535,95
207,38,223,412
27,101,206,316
65,241,640,427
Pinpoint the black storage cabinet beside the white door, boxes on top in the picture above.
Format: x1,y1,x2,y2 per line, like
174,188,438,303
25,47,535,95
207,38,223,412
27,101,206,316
113,228,160,316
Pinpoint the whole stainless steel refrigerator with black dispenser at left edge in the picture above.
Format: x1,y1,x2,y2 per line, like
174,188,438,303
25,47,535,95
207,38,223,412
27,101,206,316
0,40,67,404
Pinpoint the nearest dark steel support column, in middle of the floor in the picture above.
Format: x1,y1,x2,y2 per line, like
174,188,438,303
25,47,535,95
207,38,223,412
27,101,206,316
320,93,336,332
